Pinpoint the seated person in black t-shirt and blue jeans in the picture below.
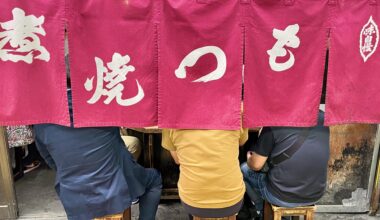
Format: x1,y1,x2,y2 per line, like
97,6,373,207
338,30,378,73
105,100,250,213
241,111,330,214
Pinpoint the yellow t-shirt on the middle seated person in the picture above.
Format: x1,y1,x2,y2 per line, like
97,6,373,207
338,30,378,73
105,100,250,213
162,129,248,208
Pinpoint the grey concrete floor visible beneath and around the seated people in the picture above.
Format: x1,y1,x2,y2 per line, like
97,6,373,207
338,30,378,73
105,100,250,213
15,168,380,220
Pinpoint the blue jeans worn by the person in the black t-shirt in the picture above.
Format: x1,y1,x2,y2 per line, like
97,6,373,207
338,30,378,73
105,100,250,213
240,163,315,210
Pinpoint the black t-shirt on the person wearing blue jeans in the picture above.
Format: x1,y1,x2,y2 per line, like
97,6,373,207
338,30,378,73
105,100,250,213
251,113,330,203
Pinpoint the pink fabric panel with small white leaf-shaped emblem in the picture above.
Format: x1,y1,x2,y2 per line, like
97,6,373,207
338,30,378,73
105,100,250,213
326,0,380,125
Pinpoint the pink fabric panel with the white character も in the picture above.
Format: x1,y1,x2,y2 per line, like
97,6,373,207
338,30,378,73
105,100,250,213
244,0,328,127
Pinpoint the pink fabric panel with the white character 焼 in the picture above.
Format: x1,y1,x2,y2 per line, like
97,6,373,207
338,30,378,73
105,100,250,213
68,0,158,127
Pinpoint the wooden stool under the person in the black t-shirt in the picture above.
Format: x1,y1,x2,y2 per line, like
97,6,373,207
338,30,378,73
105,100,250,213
264,202,316,220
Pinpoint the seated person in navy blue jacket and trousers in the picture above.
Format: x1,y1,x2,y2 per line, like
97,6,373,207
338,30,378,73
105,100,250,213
34,89,162,220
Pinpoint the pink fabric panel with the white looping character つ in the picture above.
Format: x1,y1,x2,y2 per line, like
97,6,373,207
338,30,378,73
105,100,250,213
159,0,243,129
